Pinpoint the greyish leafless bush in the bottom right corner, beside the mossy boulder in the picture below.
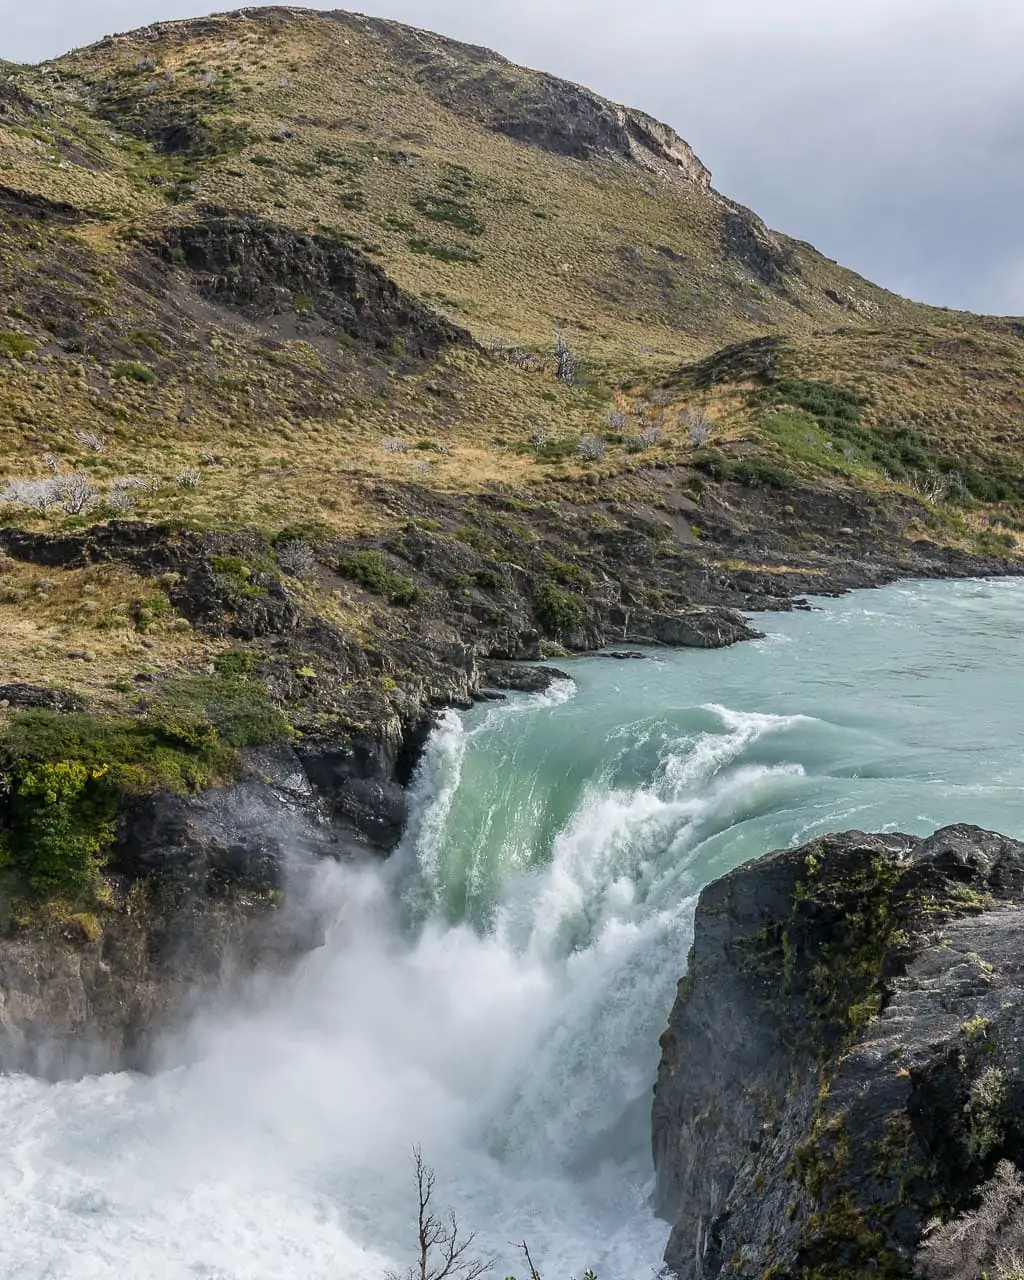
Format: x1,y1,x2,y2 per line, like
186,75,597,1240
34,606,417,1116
916,1160,1024,1280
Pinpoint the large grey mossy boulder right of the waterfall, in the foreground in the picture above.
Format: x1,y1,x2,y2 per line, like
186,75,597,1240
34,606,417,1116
653,827,1024,1280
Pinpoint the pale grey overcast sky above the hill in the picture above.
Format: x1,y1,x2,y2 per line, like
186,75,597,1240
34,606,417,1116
0,0,1024,315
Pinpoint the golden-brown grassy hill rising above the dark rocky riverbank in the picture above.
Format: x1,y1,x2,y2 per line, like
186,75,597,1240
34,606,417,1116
0,8,1024,529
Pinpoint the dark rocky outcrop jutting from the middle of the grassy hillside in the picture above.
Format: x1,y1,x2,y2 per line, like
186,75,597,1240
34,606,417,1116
155,209,472,360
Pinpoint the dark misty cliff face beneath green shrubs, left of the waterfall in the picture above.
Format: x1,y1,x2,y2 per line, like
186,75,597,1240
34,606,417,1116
0,746,394,1079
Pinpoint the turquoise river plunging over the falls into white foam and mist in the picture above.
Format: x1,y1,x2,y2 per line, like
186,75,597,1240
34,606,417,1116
0,581,1024,1280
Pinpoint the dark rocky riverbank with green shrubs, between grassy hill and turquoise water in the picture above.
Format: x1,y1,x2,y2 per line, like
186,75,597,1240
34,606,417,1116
0,468,1019,1075
